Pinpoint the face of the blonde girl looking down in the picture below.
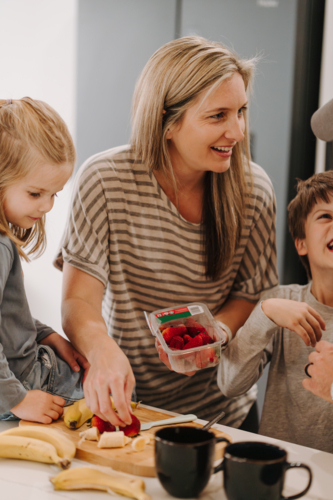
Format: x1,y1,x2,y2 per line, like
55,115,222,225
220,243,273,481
4,162,73,229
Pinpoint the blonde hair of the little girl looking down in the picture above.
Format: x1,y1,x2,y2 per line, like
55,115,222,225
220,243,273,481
0,97,76,260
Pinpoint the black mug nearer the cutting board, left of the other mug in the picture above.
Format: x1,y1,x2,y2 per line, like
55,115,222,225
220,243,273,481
155,426,229,498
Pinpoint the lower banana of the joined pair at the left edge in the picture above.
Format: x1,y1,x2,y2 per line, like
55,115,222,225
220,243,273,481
0,435,71,469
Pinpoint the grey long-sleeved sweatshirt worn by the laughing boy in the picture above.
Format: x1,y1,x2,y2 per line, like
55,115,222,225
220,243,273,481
218,283,333,453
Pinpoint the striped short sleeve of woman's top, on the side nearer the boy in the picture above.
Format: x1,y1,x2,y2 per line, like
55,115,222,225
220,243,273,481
230,165,278,302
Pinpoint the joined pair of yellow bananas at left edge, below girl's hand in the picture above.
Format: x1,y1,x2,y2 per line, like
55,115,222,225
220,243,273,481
0,425,76,469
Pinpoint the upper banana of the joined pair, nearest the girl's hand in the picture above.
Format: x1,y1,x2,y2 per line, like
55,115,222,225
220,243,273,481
0,425,76,459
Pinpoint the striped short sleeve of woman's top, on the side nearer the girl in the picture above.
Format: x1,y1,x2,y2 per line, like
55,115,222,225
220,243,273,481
54,158,112,286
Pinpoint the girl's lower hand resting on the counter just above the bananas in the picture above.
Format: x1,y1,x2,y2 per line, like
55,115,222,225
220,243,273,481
10,390,65,424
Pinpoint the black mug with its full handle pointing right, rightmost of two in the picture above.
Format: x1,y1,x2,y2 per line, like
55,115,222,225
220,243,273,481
221,441,312,500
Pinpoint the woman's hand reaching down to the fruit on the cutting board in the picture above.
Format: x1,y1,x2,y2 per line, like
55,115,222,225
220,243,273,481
83,337,135,426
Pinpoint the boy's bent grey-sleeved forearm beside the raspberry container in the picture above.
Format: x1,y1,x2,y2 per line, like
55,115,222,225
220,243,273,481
217,304,279,397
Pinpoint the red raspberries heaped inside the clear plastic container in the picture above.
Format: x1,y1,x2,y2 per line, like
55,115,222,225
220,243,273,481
161,318,214,351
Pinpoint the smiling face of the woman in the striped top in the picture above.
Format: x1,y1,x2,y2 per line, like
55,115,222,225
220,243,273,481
167,73,247,175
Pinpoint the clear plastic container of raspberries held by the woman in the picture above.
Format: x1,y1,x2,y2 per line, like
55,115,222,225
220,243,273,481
145,302,228,373
